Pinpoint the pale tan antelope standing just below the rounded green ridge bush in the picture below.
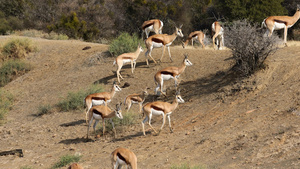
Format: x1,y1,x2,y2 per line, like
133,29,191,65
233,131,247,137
113,44,144,83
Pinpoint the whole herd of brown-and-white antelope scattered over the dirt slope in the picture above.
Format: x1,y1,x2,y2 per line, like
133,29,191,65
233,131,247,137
79,5,300,169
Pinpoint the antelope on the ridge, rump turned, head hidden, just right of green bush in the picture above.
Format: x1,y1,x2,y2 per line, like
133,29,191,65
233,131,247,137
142,19,164,38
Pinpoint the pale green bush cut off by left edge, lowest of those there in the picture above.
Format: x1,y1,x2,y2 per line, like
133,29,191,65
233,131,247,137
0,90,14,124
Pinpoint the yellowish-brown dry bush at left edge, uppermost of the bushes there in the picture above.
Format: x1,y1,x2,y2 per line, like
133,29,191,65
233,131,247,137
2,38,36,60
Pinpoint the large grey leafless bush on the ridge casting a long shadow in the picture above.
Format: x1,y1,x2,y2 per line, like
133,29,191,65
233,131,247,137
224,20,281,76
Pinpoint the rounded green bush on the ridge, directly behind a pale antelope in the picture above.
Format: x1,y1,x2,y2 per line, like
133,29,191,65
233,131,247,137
108,32,141,56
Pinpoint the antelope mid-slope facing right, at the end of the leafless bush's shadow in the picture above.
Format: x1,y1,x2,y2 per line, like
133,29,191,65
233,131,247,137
154,55,193,96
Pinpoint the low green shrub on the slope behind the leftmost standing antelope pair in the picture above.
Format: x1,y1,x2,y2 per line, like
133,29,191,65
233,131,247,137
56,85,102,112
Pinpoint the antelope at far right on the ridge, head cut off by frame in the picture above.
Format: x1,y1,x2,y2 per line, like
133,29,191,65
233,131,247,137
262,4,300,46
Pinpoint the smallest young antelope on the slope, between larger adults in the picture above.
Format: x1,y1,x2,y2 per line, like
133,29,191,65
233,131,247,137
124,89,148,113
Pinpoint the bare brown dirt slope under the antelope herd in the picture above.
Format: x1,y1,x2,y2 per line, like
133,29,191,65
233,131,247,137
0,36,300,169
